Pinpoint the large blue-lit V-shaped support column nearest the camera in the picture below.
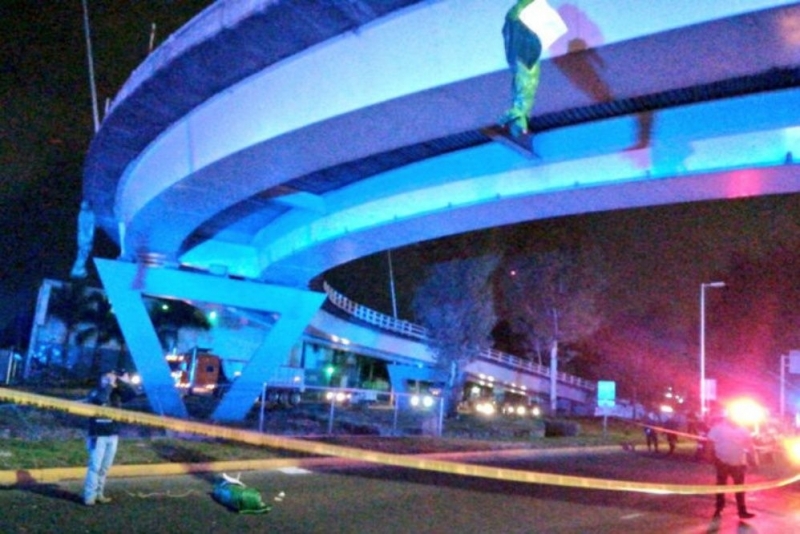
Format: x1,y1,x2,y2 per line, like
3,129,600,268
95,259,325,421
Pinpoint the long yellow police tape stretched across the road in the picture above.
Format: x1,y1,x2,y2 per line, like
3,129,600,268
0,387,800,495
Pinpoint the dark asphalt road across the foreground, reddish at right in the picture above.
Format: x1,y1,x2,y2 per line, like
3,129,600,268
0,451,800,534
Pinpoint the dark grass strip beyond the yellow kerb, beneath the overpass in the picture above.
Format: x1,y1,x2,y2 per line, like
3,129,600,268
0,396,644,470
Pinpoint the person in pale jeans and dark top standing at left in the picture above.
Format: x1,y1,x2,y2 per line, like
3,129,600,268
83,371,131,506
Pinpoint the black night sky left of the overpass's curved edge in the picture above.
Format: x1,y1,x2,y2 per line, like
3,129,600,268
0,0,211,344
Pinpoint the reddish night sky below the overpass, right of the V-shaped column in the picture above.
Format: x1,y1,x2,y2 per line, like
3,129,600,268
329,195,800,406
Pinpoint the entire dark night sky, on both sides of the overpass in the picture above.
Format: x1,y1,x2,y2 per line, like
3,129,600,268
0,0,800,408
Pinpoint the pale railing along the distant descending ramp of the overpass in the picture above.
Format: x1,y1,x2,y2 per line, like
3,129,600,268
323,282,595,390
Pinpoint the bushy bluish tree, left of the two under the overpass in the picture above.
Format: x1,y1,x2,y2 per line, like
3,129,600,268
412,255,499,415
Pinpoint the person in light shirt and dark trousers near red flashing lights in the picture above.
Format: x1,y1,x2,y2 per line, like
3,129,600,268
708,415,755,519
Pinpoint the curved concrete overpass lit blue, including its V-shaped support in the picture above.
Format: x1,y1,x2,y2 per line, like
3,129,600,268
84,0,800,420
